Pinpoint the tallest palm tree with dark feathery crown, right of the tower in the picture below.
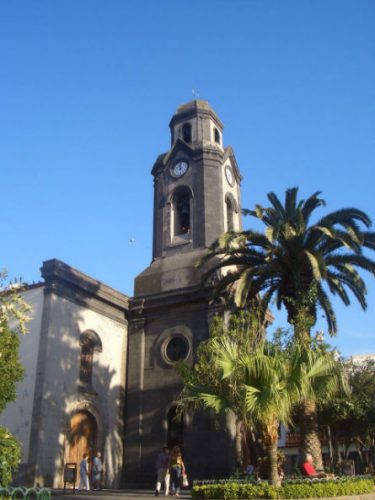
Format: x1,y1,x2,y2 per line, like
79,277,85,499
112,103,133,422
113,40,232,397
201,188,375,468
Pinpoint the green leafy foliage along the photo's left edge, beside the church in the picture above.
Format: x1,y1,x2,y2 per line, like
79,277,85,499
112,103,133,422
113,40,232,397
0,272,30,486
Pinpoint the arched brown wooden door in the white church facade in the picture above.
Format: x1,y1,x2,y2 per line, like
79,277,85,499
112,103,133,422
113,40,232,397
68,411,98,481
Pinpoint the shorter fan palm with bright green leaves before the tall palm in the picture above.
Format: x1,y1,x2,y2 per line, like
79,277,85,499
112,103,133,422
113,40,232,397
181,337,344,486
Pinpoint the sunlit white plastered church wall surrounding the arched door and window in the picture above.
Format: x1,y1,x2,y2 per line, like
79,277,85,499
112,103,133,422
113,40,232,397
31,295,127,487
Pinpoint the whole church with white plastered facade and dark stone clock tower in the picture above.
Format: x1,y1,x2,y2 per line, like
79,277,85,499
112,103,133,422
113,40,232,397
0,100,242,488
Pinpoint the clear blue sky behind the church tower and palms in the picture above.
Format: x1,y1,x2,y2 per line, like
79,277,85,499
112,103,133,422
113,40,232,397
0,0,375,355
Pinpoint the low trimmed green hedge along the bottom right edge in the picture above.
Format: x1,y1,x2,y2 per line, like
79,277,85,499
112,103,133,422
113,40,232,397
192,477,374,499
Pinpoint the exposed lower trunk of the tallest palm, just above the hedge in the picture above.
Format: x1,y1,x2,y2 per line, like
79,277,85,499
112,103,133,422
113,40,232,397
301,400,323,470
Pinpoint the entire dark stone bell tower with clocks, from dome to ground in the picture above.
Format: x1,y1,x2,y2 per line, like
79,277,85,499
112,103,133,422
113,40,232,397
124,100,242,484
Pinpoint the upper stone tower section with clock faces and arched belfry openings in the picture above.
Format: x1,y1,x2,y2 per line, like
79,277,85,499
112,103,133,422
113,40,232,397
135,100,241,296
